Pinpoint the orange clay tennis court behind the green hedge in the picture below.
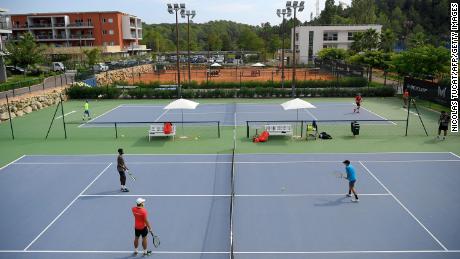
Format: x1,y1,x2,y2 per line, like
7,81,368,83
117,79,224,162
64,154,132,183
134,67,334,83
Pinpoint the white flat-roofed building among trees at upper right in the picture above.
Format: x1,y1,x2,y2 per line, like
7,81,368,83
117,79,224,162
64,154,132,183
291,24,382,64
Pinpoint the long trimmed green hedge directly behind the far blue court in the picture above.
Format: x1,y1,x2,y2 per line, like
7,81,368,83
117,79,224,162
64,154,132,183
67,86,395,99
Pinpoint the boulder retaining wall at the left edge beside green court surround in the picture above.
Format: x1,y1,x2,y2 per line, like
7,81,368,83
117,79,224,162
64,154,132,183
0,90,66,121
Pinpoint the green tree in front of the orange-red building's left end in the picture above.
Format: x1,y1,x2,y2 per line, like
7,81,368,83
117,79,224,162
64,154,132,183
7,32,46,69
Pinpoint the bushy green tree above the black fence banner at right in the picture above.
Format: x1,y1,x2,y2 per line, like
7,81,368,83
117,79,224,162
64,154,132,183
391,45,450,77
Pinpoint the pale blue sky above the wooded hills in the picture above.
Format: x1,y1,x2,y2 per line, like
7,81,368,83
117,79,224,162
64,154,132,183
0,0,351,25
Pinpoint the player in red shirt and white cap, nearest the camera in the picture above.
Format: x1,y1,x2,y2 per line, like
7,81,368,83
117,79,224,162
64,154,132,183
131,198,152,255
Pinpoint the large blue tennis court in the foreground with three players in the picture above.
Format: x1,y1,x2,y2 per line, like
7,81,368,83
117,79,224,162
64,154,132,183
0,153,460,259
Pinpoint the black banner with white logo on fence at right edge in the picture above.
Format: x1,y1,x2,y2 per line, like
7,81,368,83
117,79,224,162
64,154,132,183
404,77,450,106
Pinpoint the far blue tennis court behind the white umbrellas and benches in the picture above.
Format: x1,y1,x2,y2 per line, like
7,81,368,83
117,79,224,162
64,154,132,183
84,102,395,127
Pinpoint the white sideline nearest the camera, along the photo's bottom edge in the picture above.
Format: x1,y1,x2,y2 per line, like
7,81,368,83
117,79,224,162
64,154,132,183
0,250,460,255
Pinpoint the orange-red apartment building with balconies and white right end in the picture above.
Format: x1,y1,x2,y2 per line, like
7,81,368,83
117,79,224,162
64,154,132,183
10,11,146,54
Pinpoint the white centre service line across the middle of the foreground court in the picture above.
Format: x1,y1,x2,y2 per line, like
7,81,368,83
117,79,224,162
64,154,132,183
80,193,391,197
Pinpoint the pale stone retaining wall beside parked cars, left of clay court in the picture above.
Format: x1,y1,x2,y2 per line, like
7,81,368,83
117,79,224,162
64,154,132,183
96,64,153,86
